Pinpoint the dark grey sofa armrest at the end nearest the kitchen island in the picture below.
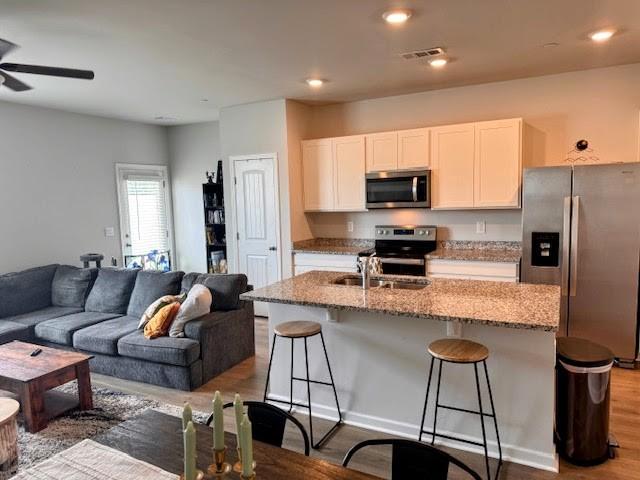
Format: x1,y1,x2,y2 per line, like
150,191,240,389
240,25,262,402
184,301,255,383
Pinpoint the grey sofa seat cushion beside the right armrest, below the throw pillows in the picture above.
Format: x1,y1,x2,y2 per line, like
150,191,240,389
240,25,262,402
118,330,200,367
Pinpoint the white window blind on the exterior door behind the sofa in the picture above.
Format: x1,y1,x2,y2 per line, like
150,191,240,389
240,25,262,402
125,175,169,255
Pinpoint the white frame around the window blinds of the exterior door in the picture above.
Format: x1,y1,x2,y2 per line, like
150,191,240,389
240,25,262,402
115,163,178,271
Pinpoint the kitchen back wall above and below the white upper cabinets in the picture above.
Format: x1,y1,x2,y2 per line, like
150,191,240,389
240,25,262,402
307,64,640,240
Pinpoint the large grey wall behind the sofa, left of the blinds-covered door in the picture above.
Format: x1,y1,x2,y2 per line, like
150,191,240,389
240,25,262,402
0,102,168,273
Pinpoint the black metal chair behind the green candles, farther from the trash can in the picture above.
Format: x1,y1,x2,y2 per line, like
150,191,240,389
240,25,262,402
207,401,310,457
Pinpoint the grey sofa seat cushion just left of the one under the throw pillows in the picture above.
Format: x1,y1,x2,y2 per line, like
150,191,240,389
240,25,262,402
73,316,138,355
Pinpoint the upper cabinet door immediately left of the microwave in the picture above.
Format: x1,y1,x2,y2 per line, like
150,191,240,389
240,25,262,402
332,135,365,211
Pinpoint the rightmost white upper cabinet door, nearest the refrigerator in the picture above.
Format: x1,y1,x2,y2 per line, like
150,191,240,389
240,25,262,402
474,119,522,208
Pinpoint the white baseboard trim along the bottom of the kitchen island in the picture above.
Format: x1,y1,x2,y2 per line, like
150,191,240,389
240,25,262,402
270,394,559,473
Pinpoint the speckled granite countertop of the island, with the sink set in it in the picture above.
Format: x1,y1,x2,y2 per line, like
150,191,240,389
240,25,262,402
241,271,560,332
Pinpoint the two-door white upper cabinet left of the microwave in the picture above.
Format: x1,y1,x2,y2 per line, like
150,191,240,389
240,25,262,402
302,135,365,212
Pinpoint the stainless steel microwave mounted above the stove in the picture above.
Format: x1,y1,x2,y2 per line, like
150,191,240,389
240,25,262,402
366,170,431,208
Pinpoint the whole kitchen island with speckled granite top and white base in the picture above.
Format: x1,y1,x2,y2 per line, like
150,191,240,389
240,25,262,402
242,271,560,471
